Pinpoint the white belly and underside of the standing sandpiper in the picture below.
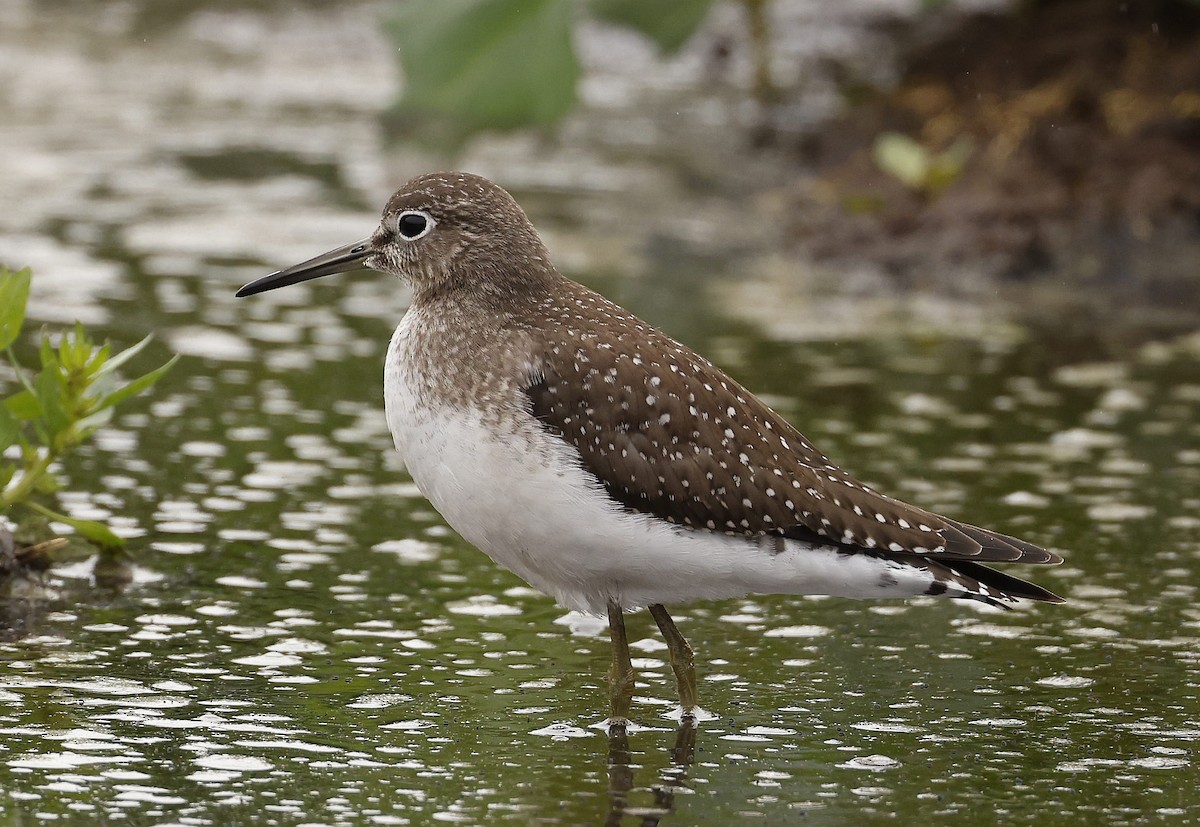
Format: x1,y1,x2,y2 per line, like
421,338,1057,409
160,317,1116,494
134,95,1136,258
384,323,931,613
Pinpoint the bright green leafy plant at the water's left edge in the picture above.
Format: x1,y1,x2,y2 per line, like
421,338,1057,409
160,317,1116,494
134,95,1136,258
0,265,178,551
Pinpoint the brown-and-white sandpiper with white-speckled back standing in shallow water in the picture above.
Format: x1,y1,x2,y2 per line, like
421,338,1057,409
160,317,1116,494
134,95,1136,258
238,173,1062,721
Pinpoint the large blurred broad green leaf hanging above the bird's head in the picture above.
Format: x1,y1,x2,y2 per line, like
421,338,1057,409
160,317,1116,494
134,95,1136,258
389,0,580,132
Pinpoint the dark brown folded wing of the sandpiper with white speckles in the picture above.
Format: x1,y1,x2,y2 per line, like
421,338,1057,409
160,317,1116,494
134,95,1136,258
524,287,1061,563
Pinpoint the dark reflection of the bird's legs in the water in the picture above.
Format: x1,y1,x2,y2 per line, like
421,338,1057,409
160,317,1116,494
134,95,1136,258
605,720,697,827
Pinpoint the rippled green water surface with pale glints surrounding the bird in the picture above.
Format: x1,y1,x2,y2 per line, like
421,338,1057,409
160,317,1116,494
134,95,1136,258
0,0,1200,826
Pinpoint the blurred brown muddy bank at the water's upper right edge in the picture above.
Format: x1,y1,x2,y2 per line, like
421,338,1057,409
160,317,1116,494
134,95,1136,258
792,0,1200,316
